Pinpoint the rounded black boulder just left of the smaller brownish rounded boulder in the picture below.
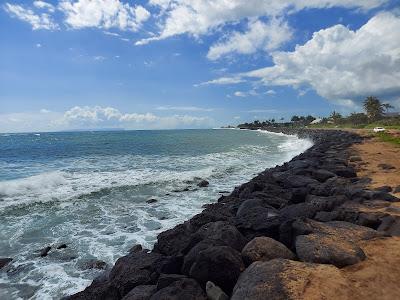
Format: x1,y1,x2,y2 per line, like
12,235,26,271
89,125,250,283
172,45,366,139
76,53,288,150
189,246,244,293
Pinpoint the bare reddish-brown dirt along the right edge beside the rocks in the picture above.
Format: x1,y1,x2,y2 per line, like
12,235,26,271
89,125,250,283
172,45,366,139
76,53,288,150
304,131,400,300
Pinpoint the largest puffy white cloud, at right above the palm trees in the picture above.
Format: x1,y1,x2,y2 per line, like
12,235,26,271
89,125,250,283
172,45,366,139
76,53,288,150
206,13,400,105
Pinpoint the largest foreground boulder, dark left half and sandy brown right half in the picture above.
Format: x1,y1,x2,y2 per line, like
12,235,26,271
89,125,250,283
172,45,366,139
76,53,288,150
231,259,350,300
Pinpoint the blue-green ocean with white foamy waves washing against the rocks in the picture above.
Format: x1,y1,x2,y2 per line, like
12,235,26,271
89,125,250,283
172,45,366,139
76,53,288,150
0,129,312,299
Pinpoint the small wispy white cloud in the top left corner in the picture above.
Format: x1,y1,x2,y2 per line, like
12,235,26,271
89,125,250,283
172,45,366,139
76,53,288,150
4,3,59,30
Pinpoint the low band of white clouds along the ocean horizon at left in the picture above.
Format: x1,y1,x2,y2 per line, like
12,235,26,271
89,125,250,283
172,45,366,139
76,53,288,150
0,106,215,132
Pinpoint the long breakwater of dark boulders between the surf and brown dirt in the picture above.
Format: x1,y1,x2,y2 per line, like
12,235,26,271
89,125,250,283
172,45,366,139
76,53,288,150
68,129,400,300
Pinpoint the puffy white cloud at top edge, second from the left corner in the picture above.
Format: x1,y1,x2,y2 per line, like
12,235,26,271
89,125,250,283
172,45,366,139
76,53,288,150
58,0,150,31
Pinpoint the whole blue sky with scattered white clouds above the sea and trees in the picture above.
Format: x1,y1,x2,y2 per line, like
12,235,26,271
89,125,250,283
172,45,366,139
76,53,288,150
0,0,400,132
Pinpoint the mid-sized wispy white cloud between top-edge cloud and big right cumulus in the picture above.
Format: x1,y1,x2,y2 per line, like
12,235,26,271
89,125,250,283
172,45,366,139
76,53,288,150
207,18,292,60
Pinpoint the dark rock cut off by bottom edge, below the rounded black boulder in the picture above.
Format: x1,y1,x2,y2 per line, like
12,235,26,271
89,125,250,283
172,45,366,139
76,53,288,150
150,279,207,300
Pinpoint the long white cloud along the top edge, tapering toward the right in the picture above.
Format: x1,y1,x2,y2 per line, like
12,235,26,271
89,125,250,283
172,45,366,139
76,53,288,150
137,0,388,48
